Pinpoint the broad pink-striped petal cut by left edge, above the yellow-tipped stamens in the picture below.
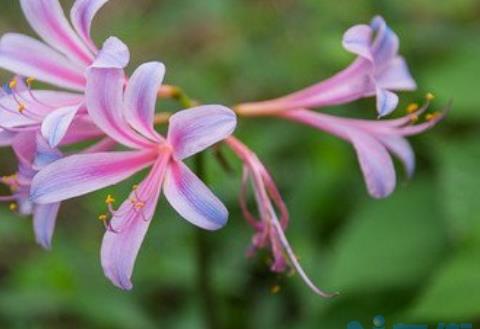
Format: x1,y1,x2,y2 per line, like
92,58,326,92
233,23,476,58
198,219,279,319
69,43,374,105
0,33,85,91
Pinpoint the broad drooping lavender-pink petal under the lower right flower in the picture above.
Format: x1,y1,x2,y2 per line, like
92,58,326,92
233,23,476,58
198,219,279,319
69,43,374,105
348,128,396,198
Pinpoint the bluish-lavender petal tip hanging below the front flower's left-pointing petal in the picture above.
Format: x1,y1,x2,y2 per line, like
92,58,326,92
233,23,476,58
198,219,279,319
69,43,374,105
33,203,60,249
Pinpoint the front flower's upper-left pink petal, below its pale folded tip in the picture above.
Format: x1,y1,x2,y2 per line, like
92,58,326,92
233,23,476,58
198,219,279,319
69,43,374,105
85,69,151,148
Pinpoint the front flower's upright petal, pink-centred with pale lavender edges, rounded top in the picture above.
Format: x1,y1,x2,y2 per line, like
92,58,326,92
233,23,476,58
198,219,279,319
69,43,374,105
125,62,165,141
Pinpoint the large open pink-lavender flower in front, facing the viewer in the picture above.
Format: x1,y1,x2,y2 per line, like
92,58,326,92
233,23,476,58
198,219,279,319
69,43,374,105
31,62,236,289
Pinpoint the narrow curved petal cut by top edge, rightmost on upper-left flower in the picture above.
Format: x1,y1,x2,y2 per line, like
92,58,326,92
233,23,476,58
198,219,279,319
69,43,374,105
70,0,108,53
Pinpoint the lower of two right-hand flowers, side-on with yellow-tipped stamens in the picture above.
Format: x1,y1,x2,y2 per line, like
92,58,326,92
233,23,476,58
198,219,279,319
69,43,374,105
278,100,445,198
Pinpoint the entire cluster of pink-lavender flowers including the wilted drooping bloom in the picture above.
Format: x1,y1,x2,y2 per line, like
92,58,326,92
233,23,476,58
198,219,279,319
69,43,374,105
0,0,444,297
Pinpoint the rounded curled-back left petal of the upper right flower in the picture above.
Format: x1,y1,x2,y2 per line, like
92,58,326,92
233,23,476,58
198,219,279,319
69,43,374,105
343,25,373,62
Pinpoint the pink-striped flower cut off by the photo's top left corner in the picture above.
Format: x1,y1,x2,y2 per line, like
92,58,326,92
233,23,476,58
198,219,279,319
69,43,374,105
0,0,129,147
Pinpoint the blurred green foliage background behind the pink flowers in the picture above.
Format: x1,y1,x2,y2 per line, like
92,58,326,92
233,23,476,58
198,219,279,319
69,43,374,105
0,0,480,329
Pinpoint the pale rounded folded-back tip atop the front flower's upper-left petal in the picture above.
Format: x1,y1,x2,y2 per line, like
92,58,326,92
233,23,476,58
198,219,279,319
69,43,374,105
91,37,130,69
